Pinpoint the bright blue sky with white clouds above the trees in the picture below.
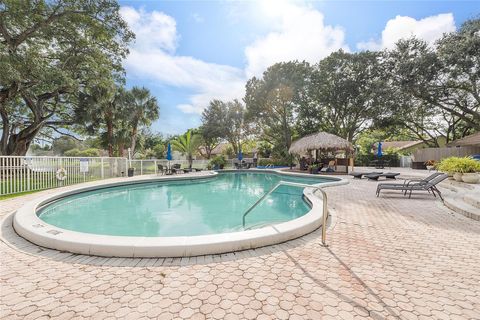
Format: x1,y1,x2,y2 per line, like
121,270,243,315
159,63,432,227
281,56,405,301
120,0,480,134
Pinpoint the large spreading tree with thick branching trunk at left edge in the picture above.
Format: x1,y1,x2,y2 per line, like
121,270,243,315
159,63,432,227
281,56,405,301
0,0,133,155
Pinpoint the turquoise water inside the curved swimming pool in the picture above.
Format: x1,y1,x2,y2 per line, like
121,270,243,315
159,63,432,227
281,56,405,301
37,172,332,237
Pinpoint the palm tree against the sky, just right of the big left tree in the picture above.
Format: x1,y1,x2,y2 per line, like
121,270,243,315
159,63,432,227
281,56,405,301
126,87,159,155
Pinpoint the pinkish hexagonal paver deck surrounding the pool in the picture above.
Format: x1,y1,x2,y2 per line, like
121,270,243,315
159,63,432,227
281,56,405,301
0,168,480,319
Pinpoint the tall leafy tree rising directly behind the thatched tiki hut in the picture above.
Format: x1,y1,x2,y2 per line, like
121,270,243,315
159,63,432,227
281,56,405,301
304,50,386,141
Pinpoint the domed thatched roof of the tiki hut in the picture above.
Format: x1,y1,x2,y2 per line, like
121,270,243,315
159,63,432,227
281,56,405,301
288,132,353,154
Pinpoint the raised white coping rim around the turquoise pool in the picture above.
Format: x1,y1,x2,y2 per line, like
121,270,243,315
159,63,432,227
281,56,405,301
13,169,348,258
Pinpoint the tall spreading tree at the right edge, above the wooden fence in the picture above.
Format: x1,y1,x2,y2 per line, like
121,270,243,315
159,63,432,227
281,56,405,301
386,19,480,140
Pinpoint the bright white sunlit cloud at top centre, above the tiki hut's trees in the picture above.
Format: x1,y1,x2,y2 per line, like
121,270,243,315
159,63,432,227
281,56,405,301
245,1,349,77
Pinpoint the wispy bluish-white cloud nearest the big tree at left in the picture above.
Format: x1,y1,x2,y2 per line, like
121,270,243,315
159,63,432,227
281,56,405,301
121,7,246,114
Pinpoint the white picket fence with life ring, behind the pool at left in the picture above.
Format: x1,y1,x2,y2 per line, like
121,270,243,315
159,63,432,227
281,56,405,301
0,156,270,195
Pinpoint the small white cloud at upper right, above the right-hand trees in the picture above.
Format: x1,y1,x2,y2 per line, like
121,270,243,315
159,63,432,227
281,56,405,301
357,13,455,50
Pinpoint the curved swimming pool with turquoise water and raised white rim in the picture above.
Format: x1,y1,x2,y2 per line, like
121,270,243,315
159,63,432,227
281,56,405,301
14,170,342,257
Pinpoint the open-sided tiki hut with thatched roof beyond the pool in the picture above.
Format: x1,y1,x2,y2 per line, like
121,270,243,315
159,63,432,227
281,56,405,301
288,132,353,173
